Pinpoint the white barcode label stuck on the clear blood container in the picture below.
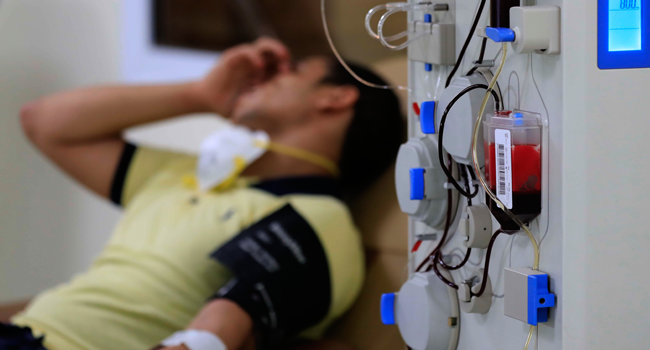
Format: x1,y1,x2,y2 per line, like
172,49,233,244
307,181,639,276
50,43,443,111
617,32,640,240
494,129,512,209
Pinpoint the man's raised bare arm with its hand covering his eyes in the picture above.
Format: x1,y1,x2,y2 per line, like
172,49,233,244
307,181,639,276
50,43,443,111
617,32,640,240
21,39,289,198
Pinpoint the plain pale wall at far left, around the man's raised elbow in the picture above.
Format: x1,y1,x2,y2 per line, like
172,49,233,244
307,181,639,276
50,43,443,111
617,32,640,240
0,0,120,301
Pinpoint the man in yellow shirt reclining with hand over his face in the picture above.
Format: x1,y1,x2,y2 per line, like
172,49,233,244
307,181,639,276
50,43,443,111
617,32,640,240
0,39,403,350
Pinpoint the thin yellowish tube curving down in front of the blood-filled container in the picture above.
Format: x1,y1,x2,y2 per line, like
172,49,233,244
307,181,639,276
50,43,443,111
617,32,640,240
472,43,539,270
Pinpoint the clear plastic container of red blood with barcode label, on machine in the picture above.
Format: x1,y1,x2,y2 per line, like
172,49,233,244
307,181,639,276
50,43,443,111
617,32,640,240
483,111,542,231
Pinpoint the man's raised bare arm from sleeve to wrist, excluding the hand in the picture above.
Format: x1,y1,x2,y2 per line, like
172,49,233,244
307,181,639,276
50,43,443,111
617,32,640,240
21,84,205,198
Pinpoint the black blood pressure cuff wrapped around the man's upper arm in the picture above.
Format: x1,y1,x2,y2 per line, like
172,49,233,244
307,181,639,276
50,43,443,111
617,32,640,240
212,205,331,350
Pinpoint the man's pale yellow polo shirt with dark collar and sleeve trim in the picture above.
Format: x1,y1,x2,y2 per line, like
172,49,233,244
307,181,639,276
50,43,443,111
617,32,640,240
13,145,364,350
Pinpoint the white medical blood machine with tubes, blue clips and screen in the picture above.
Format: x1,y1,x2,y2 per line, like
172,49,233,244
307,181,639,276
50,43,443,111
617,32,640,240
324,0,650,350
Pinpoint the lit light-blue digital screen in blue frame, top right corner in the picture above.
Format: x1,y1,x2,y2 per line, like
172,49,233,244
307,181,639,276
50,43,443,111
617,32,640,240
609,0,642,51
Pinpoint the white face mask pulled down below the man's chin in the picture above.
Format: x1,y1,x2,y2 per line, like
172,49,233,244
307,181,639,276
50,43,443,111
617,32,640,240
197,126,270,191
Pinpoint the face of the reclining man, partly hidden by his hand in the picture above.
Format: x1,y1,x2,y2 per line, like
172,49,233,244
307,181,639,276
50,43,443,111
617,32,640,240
231,58,328,132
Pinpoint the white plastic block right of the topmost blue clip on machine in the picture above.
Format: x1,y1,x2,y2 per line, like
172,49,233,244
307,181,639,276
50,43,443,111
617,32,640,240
510,6,561,55
